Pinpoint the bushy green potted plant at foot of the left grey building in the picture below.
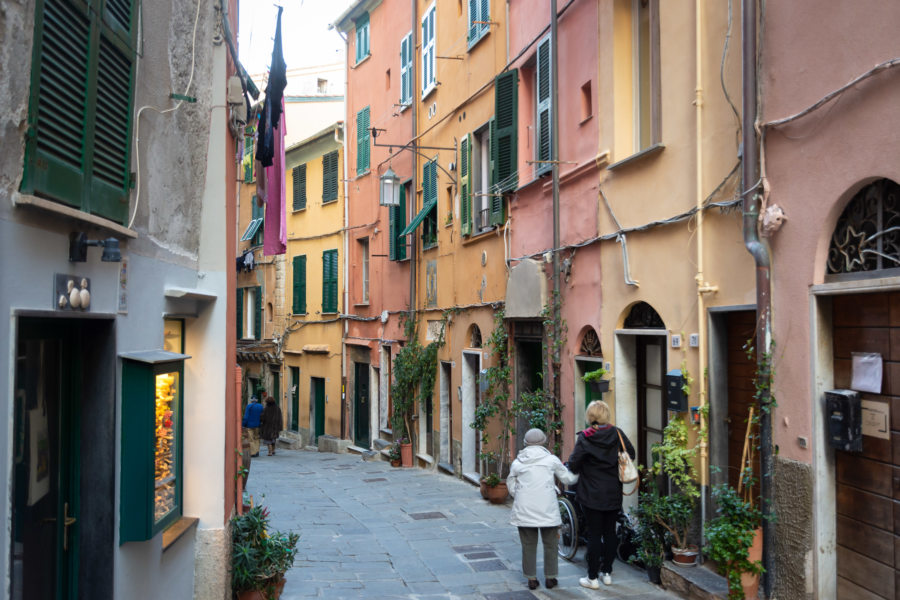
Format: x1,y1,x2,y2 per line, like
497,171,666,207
231,506,300,600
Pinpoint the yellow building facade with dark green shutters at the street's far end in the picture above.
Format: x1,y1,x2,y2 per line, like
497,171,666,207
279,122,345,445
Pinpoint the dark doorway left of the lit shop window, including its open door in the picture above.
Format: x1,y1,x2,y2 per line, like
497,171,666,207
10,317,115,600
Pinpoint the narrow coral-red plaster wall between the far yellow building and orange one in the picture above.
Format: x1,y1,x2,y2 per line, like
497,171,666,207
339,0,419,366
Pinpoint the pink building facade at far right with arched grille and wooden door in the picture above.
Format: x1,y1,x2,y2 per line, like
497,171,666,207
759,0,900,598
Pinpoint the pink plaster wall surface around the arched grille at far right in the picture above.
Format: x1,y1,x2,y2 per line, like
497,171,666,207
760,2,900,462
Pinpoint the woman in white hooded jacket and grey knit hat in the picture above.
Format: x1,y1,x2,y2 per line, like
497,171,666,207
506,429,578,590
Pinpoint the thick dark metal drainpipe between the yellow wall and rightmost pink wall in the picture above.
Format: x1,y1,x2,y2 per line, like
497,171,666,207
741,0,775,598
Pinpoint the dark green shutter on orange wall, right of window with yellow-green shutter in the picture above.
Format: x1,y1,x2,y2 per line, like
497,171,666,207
491,69,519,192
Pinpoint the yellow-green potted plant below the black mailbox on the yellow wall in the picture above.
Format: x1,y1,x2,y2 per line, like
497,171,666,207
650,419,700,566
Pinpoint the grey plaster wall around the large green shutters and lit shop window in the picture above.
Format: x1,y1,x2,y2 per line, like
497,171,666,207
0,0,233,598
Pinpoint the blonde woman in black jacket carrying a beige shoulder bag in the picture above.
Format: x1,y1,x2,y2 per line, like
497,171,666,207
568,400,635,590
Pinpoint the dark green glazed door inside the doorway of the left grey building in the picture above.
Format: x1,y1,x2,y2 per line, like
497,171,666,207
10,320,81,600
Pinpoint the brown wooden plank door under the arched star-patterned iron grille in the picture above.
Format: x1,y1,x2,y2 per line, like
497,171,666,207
822,293,900,600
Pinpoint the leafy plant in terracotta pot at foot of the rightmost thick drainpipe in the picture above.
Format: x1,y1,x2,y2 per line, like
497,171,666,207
704,483,763,600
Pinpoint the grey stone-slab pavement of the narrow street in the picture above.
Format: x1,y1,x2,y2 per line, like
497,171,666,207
247,449,676,600
